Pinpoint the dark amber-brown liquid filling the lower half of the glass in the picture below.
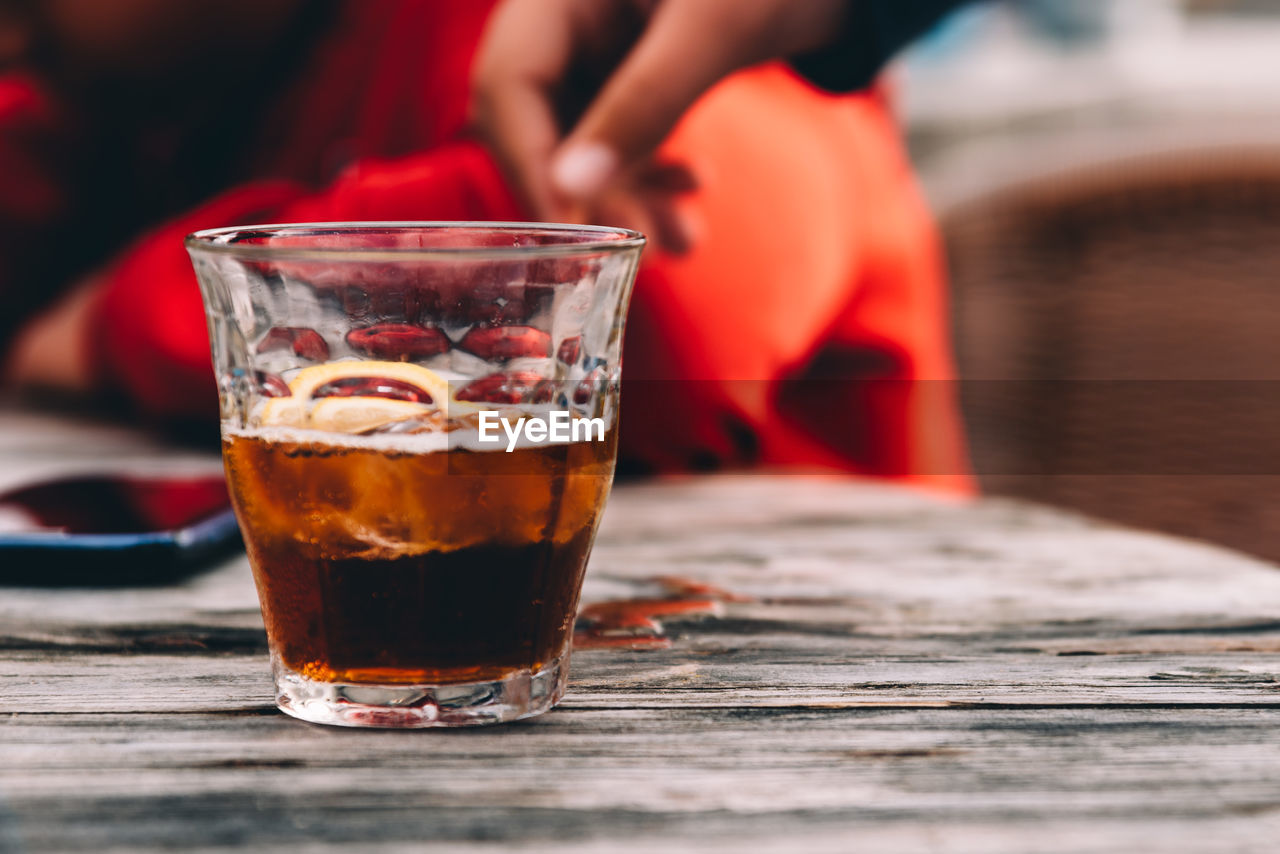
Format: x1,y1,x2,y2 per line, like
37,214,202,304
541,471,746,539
223,431,616,684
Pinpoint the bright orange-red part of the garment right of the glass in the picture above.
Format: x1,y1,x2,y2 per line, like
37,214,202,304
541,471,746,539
625,65,972,492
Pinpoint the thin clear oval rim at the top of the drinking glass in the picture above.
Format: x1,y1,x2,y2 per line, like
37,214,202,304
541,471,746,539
183,220,646,261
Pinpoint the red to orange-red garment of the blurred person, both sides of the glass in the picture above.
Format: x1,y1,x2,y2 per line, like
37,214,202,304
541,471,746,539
0,0,968,490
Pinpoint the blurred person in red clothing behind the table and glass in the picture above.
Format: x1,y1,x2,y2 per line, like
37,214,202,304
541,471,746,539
0,0,968,489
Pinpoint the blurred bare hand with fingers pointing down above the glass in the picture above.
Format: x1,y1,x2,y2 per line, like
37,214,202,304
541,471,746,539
472,0,849,251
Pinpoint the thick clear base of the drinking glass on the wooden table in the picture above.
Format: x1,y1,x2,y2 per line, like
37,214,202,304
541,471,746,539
271,654,568,730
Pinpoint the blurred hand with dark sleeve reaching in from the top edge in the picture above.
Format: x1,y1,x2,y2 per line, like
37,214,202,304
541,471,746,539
475,0,970,216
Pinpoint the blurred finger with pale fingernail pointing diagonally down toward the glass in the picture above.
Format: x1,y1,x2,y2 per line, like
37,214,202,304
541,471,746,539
550,0,755,198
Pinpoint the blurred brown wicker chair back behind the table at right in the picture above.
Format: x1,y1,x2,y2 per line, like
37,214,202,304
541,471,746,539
942,146,1280,561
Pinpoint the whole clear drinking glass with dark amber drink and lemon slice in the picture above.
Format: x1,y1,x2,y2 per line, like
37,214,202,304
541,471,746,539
187,223,644,727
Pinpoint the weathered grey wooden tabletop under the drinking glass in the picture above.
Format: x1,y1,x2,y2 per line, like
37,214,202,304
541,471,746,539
0,415,1280,854
